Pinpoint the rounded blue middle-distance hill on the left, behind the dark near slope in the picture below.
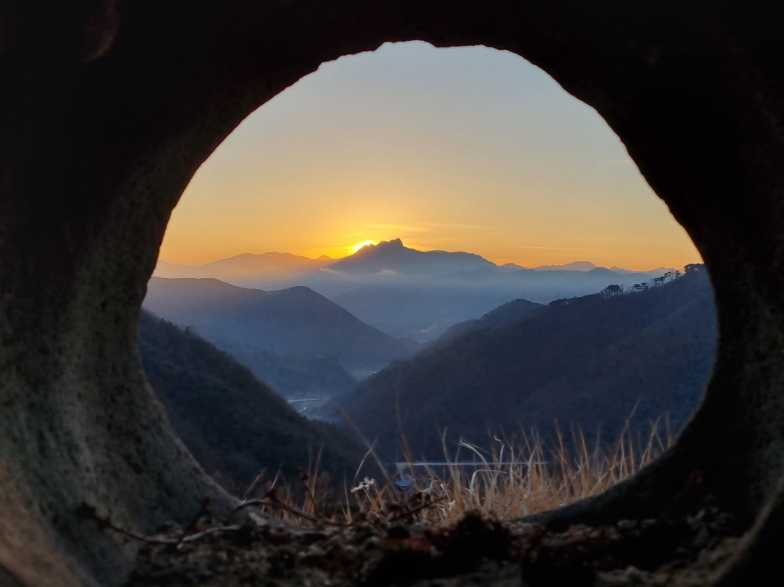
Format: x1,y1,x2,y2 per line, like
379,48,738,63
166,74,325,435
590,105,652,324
144,278,416,384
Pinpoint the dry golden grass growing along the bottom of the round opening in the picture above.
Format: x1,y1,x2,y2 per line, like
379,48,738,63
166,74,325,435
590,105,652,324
240,423,673,527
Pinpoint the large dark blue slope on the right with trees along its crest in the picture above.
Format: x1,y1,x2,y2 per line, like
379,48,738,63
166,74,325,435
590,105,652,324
334,270,717,458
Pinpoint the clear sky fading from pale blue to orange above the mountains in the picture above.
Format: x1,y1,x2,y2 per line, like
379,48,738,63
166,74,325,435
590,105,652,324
160,42,700,269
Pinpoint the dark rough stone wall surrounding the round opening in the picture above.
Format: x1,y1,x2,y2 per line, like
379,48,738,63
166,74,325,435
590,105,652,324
0,0,784,585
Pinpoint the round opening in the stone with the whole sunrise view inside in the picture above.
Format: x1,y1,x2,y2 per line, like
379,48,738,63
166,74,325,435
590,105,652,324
140,42,717,522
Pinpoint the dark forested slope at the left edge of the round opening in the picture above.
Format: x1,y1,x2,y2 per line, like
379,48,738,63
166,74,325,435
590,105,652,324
139,312,361,490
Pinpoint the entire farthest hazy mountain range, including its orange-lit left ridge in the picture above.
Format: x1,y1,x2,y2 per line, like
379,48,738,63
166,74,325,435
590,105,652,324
156,239,668,342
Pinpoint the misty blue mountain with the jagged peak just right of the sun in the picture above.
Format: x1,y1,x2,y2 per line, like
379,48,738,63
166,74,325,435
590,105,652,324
328,240,676,342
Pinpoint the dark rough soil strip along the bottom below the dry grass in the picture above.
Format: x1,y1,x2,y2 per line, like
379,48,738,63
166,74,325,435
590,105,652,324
128,506,738,587
